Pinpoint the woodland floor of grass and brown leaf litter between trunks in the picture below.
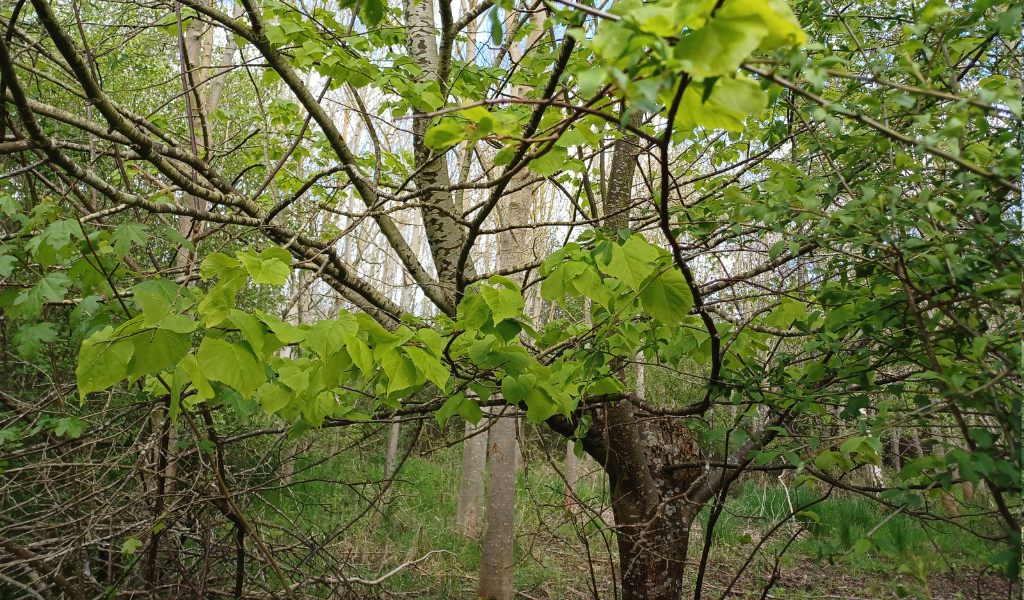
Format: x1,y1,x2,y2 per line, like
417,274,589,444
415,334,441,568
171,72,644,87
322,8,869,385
268,432,1021,600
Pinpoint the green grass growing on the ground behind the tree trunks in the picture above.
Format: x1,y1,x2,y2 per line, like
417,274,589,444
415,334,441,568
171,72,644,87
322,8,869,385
243,421,1001,598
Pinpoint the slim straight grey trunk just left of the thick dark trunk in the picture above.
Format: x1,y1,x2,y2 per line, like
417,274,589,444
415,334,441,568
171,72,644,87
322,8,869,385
477,406,518,600
